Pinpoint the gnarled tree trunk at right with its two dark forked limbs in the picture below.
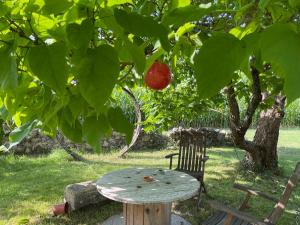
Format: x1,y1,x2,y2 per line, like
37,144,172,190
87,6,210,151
226,67,285,171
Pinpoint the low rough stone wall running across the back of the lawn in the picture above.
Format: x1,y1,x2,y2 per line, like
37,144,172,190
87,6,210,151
7,127,232,155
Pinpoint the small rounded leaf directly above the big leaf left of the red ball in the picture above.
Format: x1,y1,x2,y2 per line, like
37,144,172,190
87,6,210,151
66,19,94,48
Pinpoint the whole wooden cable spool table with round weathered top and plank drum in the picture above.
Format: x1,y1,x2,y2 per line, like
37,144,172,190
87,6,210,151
97,168,200,225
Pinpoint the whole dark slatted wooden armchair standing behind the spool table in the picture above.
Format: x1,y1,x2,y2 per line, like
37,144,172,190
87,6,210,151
165,128,208,200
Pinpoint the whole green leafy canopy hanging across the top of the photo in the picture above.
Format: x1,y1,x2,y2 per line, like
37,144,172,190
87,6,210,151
0,0,300,149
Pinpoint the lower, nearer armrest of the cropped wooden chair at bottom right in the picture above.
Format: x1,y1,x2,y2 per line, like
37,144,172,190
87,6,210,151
209,201,273,225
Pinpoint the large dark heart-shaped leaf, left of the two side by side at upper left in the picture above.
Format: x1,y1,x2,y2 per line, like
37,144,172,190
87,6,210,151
27,43,68,93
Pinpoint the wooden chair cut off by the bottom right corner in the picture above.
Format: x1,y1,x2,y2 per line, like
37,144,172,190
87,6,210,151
202,162,300,225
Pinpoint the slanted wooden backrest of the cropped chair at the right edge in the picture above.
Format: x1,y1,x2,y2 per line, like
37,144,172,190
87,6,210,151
265,162,300,224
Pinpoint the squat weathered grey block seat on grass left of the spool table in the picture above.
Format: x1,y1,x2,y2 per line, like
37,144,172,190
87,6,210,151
64,181,110,212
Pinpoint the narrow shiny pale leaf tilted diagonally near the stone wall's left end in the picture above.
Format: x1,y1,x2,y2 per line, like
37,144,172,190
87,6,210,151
8,120,37,149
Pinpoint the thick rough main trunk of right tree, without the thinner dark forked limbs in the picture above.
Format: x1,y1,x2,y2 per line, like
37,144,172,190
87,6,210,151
245,96,285,170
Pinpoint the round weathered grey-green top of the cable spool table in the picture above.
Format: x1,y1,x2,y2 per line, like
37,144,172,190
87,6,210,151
97,168,200,204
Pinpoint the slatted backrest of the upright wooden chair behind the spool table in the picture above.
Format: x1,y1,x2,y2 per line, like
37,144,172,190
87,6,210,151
177,129,206,173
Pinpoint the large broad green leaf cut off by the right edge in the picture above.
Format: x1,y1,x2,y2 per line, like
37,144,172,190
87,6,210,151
261,24,300,102
